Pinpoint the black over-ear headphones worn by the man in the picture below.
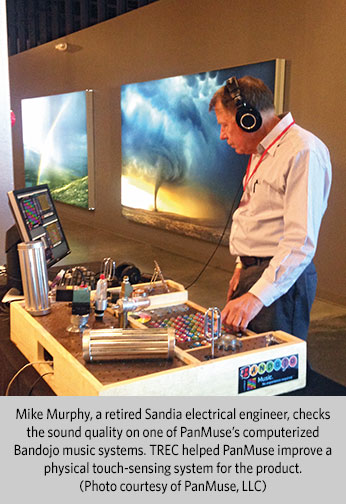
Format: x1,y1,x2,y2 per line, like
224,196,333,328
225,77,262,133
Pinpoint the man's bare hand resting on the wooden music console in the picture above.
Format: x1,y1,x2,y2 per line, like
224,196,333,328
221,292,263,330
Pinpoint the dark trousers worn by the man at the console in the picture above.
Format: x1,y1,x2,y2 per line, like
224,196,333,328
232,260,317,340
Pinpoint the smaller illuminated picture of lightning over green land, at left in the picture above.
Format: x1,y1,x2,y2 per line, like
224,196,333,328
22,91,95,209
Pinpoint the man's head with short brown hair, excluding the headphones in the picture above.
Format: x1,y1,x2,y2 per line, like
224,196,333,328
209,76,276,154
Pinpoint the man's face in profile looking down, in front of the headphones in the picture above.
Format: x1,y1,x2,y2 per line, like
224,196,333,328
215,101,258,154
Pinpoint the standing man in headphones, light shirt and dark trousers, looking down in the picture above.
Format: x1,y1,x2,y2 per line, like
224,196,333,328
209,76,331,339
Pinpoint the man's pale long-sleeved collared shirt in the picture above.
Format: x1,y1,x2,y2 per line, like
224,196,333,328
230,113,332,306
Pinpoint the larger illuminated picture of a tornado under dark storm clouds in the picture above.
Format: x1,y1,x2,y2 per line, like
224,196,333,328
121,60,284,241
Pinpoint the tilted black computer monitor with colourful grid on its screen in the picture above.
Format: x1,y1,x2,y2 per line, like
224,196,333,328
8,184,71,267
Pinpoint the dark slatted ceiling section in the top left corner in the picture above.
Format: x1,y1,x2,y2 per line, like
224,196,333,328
7,0,158,56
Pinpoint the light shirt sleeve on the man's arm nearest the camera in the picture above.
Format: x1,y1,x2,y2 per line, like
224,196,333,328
249,149,331,306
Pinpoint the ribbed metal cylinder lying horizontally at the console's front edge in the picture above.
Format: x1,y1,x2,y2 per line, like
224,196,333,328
83,327,175,362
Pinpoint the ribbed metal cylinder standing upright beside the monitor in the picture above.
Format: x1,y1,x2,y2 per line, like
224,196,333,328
18,241,50,317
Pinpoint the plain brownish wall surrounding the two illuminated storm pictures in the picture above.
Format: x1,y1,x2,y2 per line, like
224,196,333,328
10,0,346,303
